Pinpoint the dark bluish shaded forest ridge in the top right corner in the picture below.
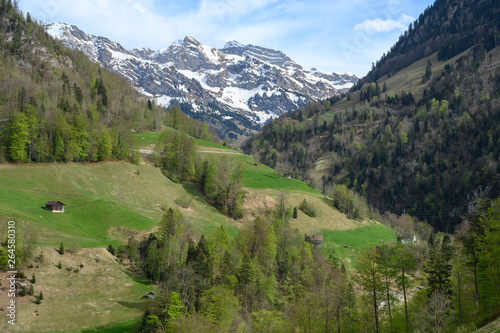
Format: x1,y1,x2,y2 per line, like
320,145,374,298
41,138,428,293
353,0,500,90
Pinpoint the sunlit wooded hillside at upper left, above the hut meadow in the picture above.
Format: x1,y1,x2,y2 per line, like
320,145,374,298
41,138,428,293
0,0,218,162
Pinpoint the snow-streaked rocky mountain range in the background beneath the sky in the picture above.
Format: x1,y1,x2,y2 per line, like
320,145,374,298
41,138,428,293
46,23,358,138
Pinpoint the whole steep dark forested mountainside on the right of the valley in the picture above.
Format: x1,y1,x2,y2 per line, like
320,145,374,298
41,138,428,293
245,0,500,230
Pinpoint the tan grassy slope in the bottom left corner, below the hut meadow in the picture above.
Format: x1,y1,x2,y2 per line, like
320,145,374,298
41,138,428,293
0,247,152,332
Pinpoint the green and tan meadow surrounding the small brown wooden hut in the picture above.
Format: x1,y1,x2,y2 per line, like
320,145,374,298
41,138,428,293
0,162,237,247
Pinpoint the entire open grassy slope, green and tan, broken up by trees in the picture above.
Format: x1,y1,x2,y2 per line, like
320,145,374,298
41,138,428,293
0,133,394,332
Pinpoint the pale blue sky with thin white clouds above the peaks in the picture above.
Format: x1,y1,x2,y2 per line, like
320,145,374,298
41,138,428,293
19,0,434,76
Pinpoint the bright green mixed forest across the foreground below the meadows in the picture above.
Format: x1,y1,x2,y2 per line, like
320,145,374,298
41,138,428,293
116,195,500,332
